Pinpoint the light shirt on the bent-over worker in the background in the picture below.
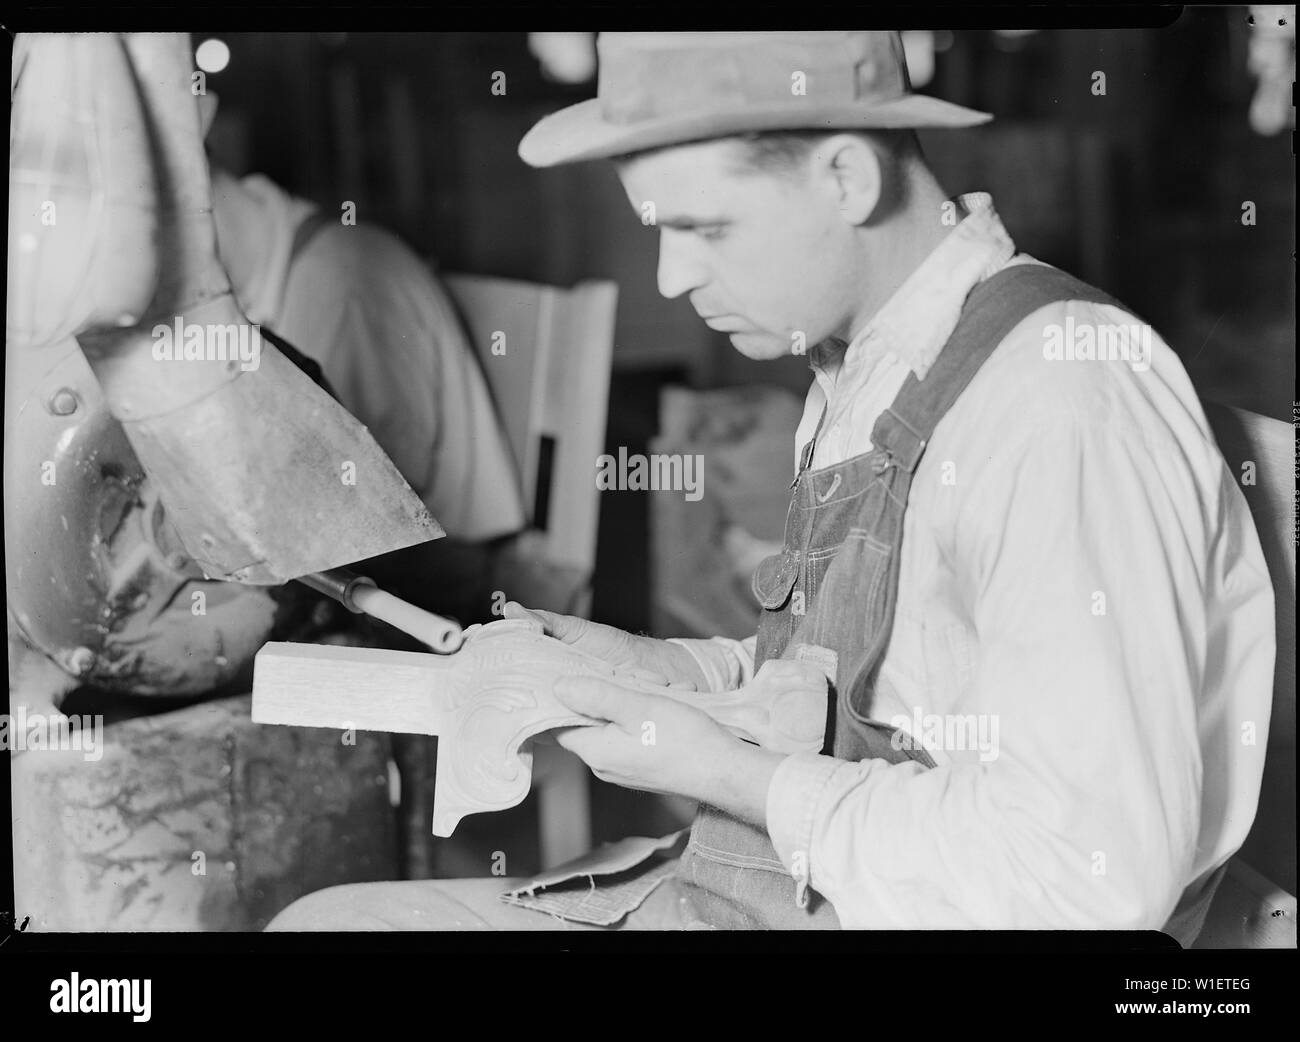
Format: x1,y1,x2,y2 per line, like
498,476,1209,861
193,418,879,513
212,170,525,540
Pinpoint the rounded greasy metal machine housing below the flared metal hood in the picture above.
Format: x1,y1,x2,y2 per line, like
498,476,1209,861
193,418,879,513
4,339,286,696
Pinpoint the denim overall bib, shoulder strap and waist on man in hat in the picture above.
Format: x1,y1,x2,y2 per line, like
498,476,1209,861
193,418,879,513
676,264,1122,929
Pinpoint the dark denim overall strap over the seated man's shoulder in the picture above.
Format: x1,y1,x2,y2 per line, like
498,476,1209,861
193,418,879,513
871,262,1128,473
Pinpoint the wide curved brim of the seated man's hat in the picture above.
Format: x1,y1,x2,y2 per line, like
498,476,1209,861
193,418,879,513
519,94,993,166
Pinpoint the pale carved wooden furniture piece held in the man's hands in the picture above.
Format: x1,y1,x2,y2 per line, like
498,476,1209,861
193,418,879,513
254,618,827,835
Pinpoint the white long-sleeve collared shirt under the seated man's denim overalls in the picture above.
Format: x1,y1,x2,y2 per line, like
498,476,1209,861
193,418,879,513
683,194,1274,942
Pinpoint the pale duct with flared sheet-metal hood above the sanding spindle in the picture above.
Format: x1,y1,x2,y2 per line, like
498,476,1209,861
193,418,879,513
7,34,443,585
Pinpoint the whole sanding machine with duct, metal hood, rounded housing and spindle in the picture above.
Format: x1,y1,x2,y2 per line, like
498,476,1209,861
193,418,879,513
4,34,460,694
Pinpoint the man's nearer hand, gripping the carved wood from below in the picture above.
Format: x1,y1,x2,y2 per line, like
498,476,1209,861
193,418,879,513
555,670,784,825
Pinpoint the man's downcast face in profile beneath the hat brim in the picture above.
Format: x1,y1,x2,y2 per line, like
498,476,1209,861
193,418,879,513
619,140,855,359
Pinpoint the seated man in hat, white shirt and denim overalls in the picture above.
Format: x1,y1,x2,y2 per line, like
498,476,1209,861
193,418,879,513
273,32,1274,942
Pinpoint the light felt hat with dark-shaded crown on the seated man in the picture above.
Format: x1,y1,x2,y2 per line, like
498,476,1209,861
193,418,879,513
519,32,993,166
